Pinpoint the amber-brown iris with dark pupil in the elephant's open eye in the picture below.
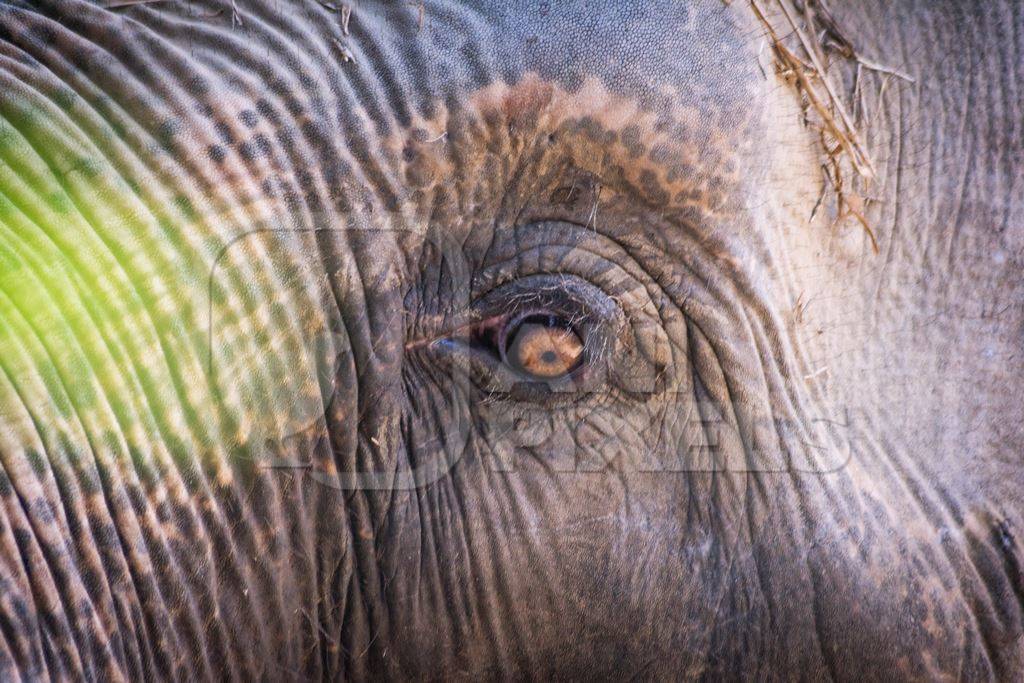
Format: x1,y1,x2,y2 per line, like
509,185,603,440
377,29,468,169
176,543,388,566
503,314,584,380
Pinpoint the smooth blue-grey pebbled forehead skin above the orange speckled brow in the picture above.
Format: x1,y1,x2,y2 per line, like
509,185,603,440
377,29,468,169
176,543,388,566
403,0,760,108
